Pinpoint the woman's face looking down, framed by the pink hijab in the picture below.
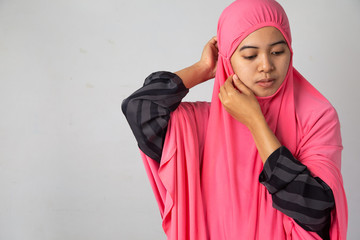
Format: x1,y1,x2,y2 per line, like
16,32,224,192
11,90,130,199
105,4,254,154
230,27,291,97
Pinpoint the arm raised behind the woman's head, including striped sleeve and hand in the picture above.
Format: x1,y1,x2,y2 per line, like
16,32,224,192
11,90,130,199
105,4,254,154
122,37,218,162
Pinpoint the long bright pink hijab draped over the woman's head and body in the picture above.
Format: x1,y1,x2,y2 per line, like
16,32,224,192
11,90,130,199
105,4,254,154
142,0,347,240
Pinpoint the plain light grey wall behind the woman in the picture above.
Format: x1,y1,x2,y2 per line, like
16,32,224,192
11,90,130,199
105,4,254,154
0,0,360,240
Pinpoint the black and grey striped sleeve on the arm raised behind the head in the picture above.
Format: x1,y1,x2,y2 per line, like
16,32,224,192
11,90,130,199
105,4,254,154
121,71,189,162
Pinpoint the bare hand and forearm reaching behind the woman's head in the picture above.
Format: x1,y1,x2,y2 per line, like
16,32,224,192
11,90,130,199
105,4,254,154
175,37,219,88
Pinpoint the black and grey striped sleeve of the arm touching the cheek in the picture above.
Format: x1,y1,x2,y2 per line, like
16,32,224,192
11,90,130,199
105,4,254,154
259,146,335,239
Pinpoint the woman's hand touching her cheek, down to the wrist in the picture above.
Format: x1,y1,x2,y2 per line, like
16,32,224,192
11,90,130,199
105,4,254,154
219,74,264,130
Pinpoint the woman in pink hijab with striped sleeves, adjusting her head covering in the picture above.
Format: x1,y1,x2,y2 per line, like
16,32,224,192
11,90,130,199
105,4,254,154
122,0,347,239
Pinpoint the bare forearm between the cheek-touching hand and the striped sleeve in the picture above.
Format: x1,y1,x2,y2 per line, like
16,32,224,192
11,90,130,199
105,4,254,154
249,115,281,163
